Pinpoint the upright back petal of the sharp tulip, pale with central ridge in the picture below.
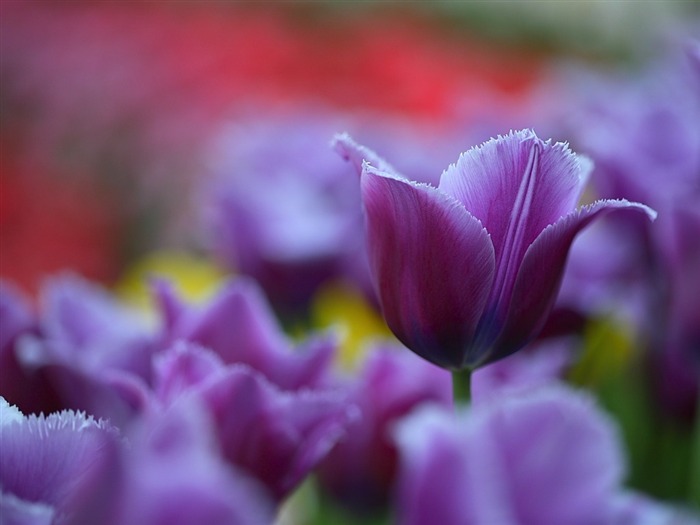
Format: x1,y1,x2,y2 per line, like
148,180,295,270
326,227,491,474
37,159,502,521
439,130,590,319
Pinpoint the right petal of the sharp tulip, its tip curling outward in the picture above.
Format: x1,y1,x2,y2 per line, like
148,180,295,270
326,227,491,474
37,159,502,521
486,200,656,365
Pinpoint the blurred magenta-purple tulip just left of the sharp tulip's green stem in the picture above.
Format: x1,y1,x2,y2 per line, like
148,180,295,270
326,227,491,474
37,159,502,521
318,345,452,515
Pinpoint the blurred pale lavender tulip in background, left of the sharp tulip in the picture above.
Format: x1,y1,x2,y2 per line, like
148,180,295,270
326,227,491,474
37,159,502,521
208,112,362,310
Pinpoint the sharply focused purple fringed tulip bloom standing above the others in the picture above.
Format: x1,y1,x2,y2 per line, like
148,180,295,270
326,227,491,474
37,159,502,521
336,130,656,370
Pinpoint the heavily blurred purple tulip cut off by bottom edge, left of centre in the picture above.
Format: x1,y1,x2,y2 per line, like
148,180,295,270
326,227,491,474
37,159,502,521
70,399,274,525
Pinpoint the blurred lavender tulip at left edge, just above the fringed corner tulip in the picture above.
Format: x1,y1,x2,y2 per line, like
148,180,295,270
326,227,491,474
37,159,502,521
2,274,157,425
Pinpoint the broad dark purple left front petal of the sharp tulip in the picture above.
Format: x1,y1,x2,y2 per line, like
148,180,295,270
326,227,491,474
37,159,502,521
361,163,494,369
